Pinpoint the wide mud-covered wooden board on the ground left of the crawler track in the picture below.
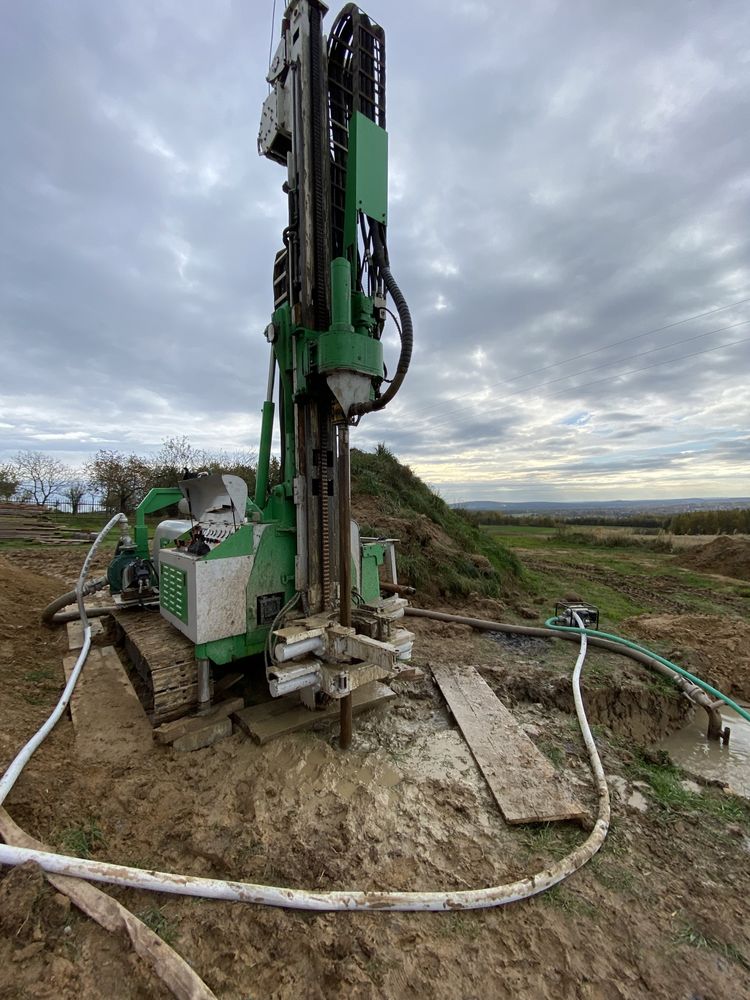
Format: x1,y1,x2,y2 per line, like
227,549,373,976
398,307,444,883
63,646,153,762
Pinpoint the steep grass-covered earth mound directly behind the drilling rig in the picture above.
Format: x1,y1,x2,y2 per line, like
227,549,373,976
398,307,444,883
351,445,521,598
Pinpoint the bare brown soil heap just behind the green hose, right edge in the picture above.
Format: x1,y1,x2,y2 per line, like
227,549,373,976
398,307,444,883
621,615,750,699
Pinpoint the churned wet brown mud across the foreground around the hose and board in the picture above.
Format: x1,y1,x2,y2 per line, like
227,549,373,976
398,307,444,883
0,549,750,1000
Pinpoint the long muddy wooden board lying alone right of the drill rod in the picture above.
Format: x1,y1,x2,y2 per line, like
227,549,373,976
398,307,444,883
432,664,588,823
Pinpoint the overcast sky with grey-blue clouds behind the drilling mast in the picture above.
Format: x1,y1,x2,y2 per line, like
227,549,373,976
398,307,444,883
0,0,750,500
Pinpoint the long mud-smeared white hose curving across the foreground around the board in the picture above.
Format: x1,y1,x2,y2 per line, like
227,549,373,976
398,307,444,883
0,584,609,910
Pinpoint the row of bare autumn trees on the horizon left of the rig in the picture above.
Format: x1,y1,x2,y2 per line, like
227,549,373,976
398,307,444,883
0,437,279,514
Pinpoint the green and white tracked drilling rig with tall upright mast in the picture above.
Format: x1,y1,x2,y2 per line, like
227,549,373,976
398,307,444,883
109,0,413,747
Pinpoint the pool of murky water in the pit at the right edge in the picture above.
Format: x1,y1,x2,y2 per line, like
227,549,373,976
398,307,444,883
661,712,750,798
